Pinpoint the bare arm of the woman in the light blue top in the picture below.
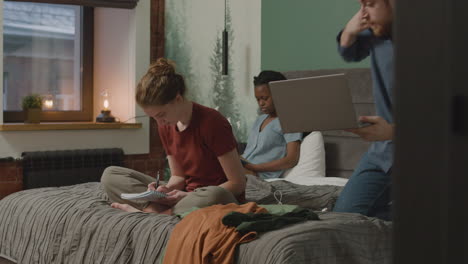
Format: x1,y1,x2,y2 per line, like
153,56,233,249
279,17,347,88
245,141,301,172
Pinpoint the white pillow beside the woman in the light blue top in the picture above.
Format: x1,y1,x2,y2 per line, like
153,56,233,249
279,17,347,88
281,131,325,184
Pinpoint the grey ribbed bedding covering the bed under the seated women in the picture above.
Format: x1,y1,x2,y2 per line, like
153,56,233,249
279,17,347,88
0,177,392,264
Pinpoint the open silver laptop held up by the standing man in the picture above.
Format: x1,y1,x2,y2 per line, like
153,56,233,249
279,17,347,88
269,74,359,133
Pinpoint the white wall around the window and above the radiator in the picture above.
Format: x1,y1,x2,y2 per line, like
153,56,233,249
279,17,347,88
0,0,150,158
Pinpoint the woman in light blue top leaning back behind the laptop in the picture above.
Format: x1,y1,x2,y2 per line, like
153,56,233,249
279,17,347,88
241,71,302,179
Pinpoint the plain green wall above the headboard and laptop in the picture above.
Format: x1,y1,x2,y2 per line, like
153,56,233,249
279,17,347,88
261,0,370,71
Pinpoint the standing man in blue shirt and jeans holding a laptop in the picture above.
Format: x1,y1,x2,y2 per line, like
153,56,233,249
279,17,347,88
333,0,394,220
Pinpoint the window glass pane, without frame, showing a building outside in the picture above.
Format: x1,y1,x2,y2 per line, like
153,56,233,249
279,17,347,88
3,1,82,111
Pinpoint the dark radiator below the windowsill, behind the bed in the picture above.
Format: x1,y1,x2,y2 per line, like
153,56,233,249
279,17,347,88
21,148,124,189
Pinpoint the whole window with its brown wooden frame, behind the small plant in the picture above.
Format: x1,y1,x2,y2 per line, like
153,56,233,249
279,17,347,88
3,1,93,122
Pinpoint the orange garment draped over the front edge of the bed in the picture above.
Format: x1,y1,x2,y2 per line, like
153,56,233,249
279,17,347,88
163,202,267,264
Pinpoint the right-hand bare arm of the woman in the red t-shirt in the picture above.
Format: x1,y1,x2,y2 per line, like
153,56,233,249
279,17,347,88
218,148,246,196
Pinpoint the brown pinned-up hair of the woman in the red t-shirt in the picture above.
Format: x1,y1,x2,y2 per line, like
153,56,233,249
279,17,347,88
135,58,185,107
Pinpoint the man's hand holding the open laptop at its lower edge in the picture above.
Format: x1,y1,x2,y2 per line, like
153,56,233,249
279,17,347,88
346,116,393,141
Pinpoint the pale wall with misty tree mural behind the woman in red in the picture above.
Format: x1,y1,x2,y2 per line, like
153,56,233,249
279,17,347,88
165,0,261,141
